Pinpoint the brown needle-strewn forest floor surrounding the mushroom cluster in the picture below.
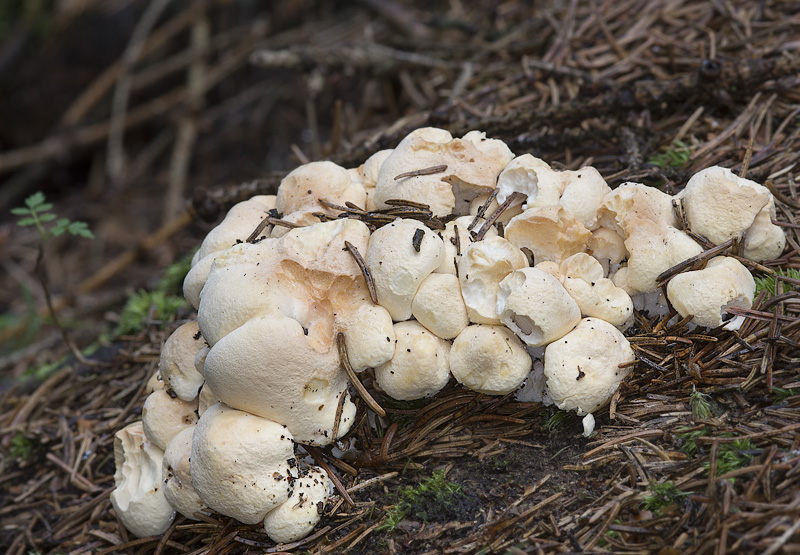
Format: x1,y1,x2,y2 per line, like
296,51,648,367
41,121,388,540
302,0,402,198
0,0,800,555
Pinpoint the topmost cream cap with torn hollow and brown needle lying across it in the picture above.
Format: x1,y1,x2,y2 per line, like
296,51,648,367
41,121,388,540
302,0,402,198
374,127,514,216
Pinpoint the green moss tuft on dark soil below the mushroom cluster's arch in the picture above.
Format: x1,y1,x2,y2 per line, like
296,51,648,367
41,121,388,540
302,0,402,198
378,470,470,532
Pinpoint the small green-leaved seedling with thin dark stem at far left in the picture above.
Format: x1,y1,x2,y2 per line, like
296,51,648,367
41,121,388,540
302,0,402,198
11,191,94,364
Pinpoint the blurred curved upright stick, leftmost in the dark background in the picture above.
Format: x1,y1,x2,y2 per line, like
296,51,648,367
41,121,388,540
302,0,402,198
106,0,170,184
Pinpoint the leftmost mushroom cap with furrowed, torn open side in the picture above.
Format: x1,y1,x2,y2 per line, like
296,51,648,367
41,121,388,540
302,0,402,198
111,422,175,538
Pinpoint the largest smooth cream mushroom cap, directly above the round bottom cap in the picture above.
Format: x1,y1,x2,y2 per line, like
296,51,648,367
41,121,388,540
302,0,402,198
205,313,355,445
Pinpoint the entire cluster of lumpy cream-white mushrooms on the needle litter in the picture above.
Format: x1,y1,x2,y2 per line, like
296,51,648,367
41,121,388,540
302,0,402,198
111,128,785,542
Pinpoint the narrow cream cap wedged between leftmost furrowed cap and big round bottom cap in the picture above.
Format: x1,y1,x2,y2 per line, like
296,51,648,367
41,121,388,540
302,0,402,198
161,426,208,520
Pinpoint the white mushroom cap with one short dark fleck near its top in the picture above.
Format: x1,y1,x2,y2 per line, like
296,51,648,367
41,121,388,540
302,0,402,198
364,219,444,321
